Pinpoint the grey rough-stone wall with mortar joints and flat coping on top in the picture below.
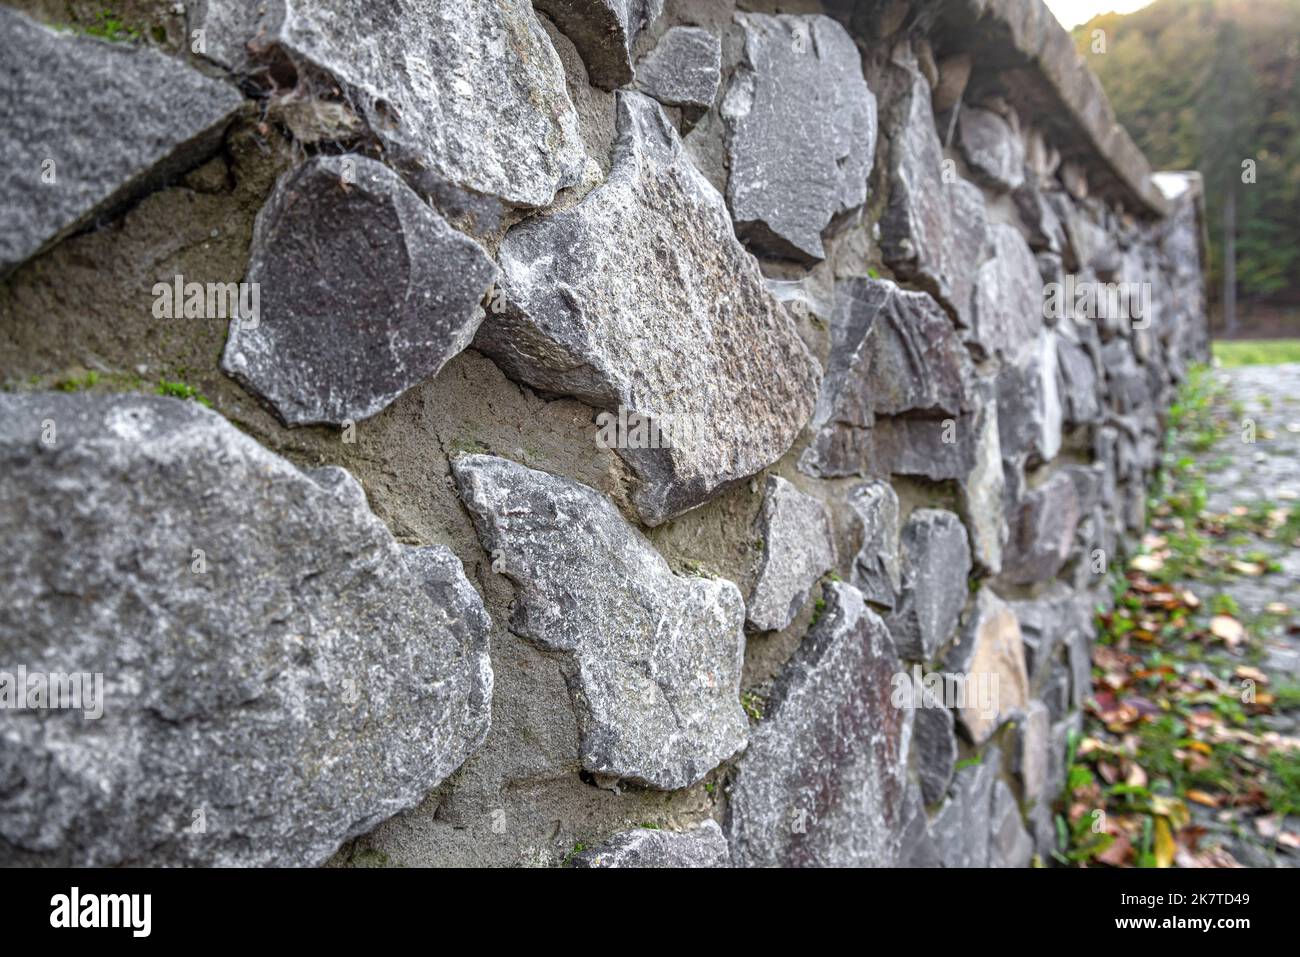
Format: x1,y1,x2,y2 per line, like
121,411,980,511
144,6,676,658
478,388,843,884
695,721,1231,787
0,0,1206,866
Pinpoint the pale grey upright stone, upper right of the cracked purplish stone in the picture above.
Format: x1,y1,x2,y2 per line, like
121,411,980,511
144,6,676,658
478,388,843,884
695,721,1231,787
963,224,1043,360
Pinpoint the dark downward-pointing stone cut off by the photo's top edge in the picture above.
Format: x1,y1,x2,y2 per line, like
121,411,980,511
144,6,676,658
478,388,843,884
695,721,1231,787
533,0,663,90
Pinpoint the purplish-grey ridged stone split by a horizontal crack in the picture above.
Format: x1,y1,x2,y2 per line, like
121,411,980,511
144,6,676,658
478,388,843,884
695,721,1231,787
800,278,971,477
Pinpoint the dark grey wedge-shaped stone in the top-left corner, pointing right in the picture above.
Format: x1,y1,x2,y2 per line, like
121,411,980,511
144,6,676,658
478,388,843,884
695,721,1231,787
0,7,243,278
